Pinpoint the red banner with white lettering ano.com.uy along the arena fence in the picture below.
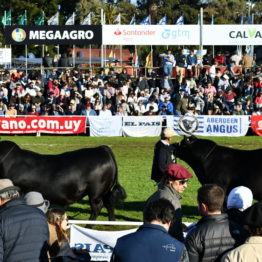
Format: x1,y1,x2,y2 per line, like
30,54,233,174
0,116,86,134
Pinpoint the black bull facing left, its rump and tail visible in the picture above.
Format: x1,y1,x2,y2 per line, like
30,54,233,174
0,141,126,220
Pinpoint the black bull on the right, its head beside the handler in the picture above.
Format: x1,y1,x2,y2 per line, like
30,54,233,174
175,136,262,200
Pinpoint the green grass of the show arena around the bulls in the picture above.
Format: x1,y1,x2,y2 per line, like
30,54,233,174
2,136,262,229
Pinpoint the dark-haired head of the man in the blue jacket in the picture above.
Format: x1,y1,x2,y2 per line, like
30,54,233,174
143,198,175,224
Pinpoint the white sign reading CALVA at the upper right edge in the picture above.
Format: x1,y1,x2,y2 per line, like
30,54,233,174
204,25,262,45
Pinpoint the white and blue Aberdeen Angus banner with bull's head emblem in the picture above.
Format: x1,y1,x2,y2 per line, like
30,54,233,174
166,115,250,136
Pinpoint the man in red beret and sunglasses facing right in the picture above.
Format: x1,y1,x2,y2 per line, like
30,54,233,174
146,164,193,242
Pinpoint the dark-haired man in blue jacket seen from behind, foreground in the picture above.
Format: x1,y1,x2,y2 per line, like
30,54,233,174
111,199,189,262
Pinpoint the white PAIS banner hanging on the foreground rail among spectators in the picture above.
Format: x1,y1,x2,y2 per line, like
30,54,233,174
70,225,137,261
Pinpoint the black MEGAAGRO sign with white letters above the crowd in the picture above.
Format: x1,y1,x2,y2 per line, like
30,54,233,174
5,25,102,45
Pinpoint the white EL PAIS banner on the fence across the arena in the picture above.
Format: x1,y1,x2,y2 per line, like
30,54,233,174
123,116,162,137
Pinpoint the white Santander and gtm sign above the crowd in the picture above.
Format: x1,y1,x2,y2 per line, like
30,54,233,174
102,25,200,45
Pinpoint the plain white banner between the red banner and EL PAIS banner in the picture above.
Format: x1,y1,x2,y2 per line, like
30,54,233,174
88,116,122,136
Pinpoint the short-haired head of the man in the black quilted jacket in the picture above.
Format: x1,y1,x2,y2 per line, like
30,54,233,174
197,184,225,215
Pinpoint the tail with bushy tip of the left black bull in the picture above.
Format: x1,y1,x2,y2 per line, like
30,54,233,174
105,146,127,204
